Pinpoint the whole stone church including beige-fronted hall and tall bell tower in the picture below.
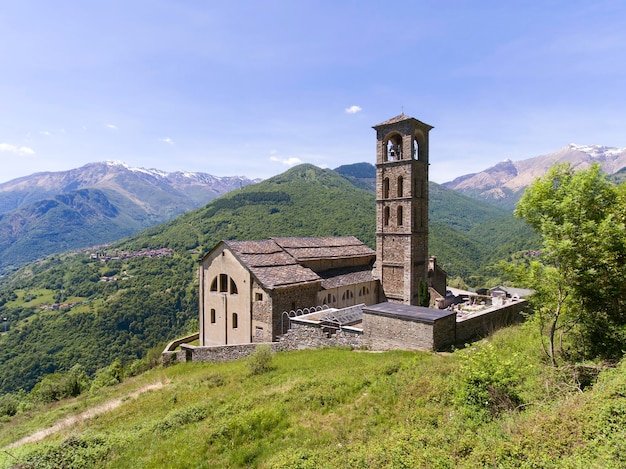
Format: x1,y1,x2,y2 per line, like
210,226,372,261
198,114,446,346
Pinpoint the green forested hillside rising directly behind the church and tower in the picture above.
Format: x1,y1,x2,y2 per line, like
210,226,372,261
0,165,533,393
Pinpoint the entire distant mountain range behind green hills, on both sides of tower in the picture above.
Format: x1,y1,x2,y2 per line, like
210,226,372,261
0,144,626,271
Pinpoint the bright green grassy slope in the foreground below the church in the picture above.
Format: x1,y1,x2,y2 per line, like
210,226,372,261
0,326,626,468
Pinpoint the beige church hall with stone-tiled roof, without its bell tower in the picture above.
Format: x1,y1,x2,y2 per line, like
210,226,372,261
199,236,378,346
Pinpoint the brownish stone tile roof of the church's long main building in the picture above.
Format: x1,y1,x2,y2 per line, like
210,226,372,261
224,236,376,289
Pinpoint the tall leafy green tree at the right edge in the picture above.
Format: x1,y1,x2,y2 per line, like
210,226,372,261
515,164,626,365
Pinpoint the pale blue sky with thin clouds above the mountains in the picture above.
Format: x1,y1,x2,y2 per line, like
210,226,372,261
0,0,626,183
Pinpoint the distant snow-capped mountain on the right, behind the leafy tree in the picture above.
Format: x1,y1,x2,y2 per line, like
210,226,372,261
443,143,626,208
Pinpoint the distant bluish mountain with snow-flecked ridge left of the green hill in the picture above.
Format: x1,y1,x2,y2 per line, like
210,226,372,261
0,161,259,270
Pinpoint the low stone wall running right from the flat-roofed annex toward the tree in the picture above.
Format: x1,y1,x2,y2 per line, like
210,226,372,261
456,300,528,344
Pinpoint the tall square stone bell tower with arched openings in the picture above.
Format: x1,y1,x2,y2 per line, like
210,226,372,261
373,113,433,305
